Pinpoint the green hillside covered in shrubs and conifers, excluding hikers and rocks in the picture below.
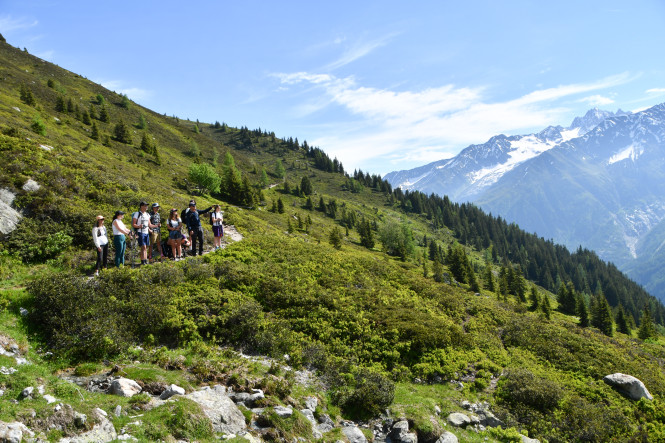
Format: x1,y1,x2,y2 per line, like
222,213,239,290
0,43,665,441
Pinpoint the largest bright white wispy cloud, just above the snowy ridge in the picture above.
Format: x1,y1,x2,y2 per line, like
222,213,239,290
275,72,632,172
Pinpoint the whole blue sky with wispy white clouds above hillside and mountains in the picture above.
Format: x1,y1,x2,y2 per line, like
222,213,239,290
0,0,665,175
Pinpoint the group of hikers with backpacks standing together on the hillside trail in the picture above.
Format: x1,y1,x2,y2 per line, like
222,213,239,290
92,200,224,275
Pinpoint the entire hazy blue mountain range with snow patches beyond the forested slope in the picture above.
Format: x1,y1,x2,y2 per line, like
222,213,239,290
386,104,665,300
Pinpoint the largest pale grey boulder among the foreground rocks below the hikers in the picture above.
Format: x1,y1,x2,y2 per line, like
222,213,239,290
185,385,247,434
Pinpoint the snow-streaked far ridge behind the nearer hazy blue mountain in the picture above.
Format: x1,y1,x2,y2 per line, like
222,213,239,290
385,109,627,201
